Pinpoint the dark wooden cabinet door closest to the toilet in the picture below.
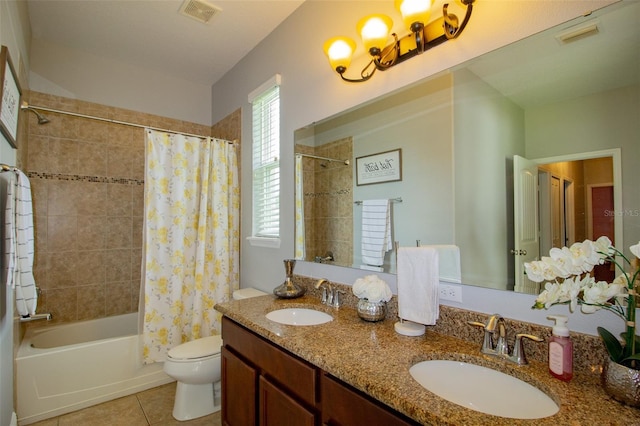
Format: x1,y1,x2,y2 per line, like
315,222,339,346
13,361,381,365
222,347,258,426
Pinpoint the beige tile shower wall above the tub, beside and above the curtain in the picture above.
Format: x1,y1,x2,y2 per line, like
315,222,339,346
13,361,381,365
24,92,211,321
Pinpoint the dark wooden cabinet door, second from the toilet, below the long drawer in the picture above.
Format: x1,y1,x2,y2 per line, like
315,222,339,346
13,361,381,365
259,376,315,426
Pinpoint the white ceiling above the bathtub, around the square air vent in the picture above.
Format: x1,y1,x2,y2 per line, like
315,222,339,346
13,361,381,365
27,0,304,86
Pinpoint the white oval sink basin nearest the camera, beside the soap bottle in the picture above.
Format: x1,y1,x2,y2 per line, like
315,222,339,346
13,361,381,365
409,360,559,419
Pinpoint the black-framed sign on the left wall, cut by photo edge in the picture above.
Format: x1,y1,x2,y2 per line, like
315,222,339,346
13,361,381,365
0,46,22,148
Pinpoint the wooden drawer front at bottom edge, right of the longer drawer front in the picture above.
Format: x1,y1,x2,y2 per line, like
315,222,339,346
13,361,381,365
321,373,418,426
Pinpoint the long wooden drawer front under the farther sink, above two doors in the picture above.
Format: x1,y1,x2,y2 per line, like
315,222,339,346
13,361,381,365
222,317,319,406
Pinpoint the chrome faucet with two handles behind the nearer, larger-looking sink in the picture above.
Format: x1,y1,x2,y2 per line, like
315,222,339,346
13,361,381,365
468,314,544,365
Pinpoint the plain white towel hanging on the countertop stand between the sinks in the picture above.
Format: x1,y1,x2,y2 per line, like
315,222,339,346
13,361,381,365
397,247,440,325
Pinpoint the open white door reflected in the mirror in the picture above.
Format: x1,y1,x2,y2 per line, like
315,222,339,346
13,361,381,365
511,155,540,294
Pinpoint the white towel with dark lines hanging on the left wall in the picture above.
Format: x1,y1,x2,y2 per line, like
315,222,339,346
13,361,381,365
5,170,38,316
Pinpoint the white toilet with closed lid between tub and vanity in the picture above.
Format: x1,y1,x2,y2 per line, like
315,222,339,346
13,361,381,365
164,288,267,421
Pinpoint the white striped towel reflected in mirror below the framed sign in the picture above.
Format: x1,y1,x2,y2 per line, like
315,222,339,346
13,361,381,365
362,200,393,266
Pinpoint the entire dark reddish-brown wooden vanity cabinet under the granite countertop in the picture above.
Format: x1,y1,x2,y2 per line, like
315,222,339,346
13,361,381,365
222,317,418,426
